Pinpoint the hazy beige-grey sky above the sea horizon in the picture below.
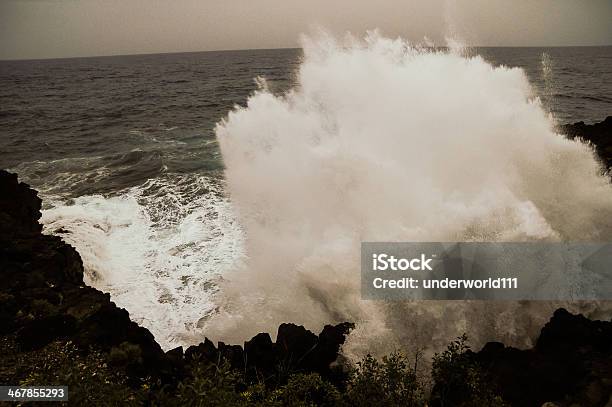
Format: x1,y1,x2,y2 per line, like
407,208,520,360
0,0,612,59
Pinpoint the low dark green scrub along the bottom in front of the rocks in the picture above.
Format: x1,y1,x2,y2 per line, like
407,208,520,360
0,334,506,407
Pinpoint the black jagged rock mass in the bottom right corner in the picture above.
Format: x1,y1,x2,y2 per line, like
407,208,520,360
473,309,612,407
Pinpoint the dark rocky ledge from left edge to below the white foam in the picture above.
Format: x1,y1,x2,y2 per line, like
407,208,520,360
0,170,353,383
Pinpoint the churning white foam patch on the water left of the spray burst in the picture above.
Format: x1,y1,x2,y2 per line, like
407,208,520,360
42,176,243,348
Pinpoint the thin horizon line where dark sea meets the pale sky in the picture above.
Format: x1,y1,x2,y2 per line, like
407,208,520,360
0,44,612,62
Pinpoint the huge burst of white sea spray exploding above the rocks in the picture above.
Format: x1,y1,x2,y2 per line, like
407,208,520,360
209,32,612,356
